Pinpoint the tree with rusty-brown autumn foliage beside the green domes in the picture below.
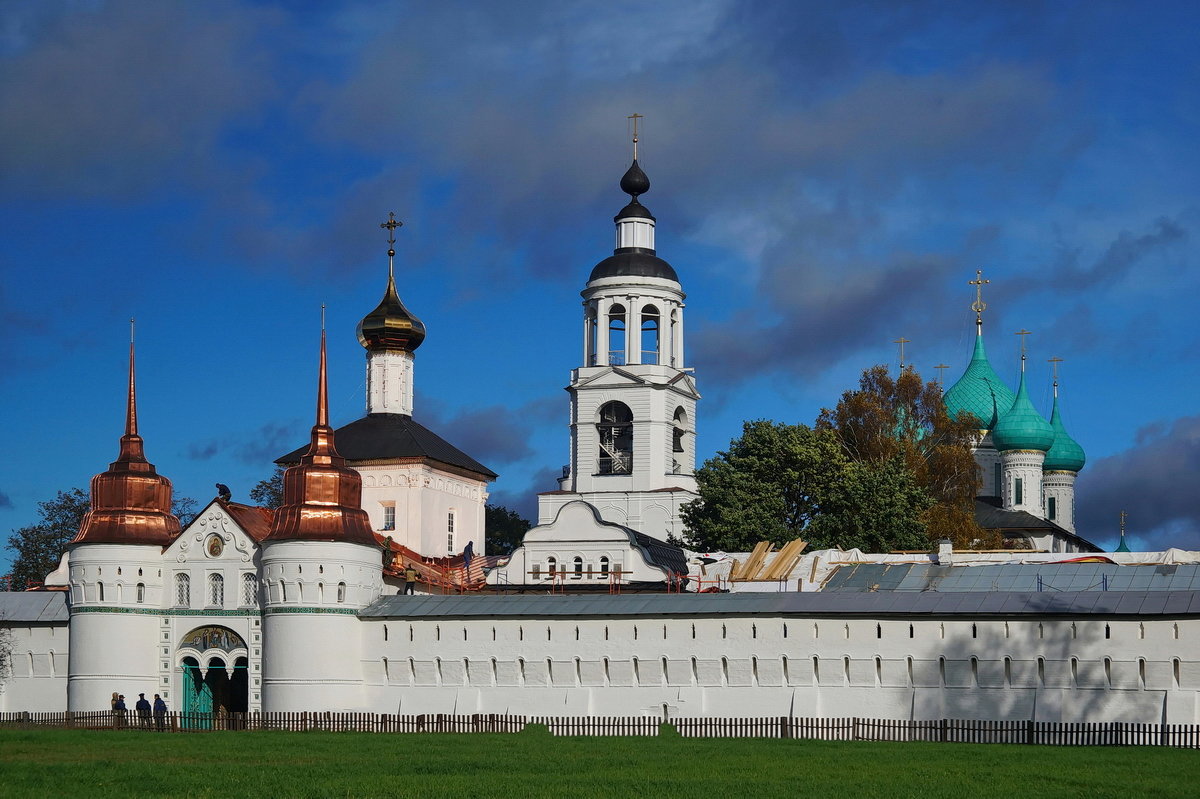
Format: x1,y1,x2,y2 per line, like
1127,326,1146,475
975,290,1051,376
817,366,1003,548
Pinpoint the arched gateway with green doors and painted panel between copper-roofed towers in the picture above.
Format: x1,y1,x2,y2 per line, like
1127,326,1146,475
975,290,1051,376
175,626,250,715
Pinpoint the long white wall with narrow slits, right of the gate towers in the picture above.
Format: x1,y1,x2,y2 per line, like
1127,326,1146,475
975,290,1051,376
362,609,1200,723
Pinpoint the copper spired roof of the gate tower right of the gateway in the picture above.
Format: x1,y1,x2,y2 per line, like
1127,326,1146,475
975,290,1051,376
266,330,377,547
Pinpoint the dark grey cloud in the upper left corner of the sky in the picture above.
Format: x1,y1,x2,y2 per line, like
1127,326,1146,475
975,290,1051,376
0,0,276,197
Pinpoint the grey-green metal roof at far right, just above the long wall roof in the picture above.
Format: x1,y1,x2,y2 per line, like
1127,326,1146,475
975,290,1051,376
822,563,1200,593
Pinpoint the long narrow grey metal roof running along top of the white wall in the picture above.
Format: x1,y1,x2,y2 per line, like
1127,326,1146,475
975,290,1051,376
359,590,1200,619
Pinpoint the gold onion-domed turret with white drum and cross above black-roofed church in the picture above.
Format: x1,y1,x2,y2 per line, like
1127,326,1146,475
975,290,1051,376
358,214,425,416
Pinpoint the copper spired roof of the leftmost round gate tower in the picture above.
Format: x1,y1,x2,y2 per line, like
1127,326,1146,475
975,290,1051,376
71,342,179,546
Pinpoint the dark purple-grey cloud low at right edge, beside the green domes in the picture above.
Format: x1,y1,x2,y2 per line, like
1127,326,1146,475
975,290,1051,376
1076,415,1200,549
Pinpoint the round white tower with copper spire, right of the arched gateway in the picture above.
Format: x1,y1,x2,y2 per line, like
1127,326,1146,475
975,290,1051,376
263,330,383,711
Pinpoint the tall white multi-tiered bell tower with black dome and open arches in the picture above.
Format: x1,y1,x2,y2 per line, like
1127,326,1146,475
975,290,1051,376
538,119,700,540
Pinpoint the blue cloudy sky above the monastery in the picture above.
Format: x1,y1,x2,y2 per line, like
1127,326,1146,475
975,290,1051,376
0,0,1200,573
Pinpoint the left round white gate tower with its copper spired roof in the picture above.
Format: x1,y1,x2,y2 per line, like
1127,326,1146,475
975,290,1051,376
67,323,179,710
